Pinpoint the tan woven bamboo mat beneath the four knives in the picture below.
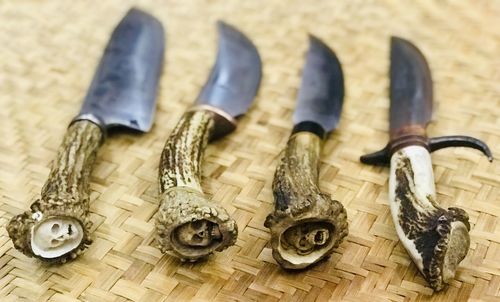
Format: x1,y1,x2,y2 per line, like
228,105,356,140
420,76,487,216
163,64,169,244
0,0,500,301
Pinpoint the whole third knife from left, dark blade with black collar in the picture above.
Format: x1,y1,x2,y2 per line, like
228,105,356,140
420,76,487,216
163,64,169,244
264,36,348,269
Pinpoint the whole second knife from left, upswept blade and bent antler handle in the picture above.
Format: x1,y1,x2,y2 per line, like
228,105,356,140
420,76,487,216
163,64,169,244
156,21,262,262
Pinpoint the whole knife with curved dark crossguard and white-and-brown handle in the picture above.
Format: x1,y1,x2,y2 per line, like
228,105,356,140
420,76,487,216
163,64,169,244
361,37,493,291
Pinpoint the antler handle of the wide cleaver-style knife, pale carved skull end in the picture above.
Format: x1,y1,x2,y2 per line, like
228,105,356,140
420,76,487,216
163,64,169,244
7,120,103,263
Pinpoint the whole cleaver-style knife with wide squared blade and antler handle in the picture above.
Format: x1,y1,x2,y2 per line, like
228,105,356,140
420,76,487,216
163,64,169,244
7,9,164,263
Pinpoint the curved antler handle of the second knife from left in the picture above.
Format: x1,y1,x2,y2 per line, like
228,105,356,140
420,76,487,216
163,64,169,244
156,109,238,261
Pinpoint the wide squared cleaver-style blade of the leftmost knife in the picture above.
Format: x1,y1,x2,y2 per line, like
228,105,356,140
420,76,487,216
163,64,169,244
76,9,165,131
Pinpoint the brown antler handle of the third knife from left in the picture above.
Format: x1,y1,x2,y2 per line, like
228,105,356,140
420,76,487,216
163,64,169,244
264,132,348,269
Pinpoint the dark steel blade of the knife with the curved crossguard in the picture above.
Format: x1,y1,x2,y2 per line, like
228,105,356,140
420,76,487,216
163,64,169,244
390,37,432,132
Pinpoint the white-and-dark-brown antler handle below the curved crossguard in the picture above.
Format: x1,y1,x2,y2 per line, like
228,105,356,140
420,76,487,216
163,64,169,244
389,146,470,290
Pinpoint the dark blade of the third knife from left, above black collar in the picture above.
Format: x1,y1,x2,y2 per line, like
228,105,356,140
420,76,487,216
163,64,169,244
293,35,344,132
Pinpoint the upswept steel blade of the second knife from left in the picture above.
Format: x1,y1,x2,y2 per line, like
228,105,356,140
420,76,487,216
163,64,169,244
197,21,262,117
